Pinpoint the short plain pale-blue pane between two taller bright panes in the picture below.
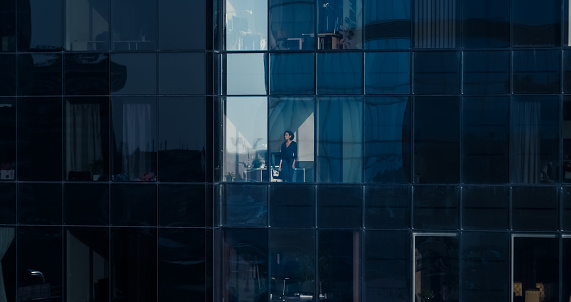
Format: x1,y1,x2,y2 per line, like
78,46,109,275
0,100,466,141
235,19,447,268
226,53,267,95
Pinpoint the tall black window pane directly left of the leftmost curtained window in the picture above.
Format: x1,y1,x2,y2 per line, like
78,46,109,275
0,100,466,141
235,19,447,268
18,98,62,181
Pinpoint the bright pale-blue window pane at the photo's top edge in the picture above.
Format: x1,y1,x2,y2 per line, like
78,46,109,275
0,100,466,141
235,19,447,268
226,0,268,50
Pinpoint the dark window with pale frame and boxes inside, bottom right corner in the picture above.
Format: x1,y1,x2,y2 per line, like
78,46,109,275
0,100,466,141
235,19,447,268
512,236,566,302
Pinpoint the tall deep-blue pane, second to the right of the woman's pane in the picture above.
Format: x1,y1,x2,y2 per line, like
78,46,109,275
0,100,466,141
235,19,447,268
364,97,411,183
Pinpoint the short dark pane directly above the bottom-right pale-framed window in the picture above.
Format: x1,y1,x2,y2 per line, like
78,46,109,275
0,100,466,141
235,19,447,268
512,187,559,231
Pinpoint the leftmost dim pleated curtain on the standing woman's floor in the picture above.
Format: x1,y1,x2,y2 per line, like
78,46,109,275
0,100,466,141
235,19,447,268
66,102,103,175
